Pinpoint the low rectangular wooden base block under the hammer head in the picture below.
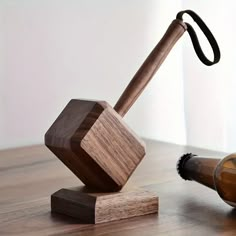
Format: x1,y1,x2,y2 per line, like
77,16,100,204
51,188,158,224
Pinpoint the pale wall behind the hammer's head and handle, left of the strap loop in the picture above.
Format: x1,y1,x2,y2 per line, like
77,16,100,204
0,0,185,148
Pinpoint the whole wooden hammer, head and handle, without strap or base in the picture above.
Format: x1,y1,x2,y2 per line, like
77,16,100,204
45,20,186,191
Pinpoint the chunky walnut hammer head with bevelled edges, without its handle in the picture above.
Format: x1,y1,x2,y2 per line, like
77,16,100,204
45,100,145,191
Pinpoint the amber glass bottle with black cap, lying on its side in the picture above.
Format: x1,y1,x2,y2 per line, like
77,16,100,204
177,153,236,207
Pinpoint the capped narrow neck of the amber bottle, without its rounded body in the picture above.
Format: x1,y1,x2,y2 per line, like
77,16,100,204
178,154,220,190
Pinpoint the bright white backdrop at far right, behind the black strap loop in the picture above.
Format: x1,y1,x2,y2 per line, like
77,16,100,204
183,0,236,152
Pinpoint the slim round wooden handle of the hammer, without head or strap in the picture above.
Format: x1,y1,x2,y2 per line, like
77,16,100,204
114,19,187,116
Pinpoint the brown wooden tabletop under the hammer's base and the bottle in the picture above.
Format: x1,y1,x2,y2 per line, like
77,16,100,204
0,140,236,236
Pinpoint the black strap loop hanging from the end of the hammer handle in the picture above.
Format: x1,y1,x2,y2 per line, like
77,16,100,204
176,10,220,66
